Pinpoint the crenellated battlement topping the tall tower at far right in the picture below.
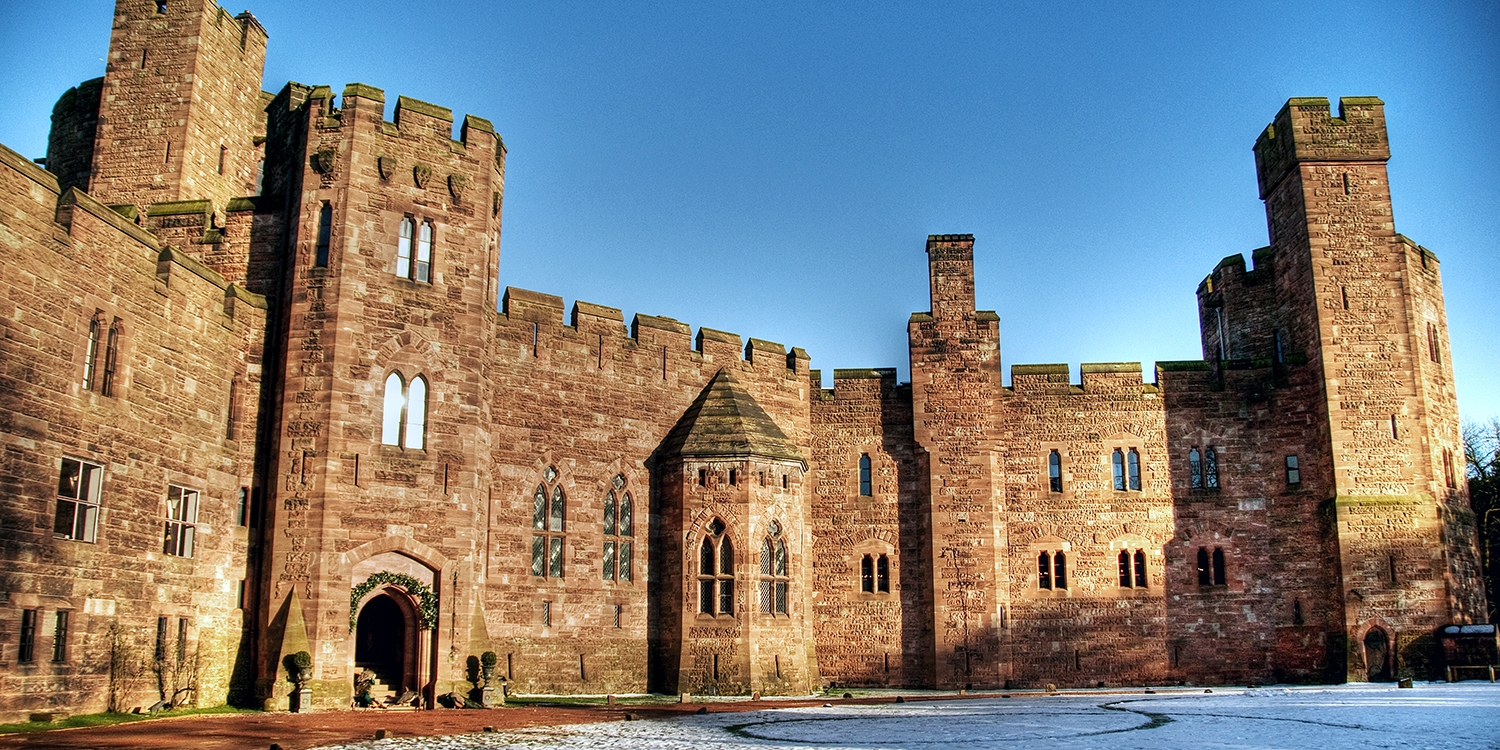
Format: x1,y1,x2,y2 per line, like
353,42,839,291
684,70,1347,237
1256,96,1391,198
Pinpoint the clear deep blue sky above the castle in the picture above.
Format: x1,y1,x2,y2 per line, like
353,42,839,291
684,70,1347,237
0,0,1500,419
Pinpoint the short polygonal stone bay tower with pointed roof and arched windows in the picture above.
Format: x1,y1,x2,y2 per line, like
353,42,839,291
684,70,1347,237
651,369,819,695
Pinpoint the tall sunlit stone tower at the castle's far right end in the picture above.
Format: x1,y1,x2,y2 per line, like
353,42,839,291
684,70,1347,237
1256,98,1484,680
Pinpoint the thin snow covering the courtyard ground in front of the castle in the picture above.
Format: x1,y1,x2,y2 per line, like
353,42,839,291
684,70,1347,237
313,683,1500,750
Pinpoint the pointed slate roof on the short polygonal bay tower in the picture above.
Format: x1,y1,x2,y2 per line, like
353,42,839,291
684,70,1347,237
662,369,807,465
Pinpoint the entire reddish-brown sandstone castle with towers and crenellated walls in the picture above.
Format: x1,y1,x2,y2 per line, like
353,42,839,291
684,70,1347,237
0,0,1485,720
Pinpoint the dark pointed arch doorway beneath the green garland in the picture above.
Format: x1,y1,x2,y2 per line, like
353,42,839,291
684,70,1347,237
354,588,422,701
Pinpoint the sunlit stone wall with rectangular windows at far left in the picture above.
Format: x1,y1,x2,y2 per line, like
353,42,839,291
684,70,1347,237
0,149,266,716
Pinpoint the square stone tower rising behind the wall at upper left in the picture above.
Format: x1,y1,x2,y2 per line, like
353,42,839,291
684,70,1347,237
81,0,267,210
